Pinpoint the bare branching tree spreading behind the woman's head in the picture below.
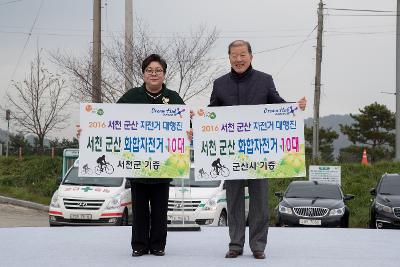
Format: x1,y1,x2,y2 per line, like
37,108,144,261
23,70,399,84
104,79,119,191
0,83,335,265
50,21,220,103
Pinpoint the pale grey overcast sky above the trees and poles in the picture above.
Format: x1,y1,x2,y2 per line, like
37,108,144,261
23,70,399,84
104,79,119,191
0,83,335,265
0,0,397,138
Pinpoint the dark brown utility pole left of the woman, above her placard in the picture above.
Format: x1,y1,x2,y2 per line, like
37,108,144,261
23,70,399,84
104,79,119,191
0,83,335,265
92,0,101,103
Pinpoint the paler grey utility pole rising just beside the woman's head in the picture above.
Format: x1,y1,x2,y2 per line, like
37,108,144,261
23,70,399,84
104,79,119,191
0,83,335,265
125,0,133,91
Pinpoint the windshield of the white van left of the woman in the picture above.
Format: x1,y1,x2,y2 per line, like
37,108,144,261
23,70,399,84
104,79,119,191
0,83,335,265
62,167,124,187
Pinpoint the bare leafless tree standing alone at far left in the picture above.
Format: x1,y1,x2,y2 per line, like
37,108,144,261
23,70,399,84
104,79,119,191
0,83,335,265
7,51,71,149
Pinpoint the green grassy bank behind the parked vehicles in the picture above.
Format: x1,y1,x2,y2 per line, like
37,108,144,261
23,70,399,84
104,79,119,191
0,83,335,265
0,156,400,228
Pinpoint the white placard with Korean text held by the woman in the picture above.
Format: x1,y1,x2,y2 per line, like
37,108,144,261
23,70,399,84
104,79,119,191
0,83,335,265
79,103,190,178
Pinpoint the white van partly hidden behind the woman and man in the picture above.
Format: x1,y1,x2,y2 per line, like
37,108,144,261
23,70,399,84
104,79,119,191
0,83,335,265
168,168,249,226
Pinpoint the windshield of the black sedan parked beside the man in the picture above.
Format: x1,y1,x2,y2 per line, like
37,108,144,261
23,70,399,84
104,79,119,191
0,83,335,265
285,183,342,199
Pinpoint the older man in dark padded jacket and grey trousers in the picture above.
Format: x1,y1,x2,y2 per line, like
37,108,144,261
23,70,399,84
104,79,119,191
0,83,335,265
210,40,306,259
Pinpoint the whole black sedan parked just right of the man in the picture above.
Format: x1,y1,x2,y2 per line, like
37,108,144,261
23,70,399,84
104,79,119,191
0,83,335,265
275,181,354,227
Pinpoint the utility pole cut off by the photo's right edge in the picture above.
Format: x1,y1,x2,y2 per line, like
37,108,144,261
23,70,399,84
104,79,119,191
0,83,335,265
395,0,400,161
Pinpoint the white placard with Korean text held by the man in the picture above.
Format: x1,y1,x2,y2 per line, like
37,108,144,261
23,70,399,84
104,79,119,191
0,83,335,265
193,103,306,180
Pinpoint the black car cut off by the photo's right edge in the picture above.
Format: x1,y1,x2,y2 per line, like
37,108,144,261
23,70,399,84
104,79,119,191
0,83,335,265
369,174,400,229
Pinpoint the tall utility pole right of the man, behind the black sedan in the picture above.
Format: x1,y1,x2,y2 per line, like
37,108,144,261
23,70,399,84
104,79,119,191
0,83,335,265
312,0,324,163
